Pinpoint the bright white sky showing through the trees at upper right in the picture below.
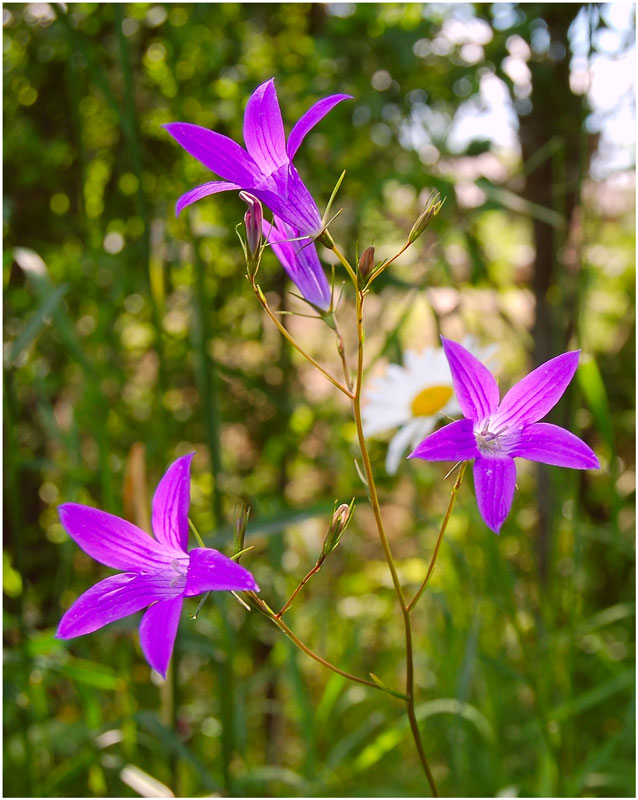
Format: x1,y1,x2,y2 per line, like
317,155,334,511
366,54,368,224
400,2,635,178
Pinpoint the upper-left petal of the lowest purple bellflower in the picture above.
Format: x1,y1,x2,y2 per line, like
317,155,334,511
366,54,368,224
58,503,171,572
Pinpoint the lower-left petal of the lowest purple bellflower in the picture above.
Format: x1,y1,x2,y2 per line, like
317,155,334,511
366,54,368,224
55,572,183,639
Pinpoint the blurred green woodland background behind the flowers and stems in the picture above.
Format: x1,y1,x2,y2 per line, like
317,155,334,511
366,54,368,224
2,3,635,797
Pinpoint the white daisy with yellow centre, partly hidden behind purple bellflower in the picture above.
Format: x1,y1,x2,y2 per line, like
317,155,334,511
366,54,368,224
362,336,496,475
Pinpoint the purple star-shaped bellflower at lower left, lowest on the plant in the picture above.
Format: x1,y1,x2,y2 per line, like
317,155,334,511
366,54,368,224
56,454,259,678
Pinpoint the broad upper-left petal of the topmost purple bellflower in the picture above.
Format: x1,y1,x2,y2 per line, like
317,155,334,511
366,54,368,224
164,122,261,186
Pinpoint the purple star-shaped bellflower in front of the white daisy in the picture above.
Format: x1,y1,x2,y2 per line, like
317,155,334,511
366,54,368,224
409,337,600,533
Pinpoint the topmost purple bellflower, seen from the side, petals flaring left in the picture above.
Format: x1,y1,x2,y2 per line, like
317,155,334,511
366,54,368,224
164,78,350,237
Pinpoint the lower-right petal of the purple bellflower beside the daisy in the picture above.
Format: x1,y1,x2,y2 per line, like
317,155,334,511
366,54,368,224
509,422,600,469
